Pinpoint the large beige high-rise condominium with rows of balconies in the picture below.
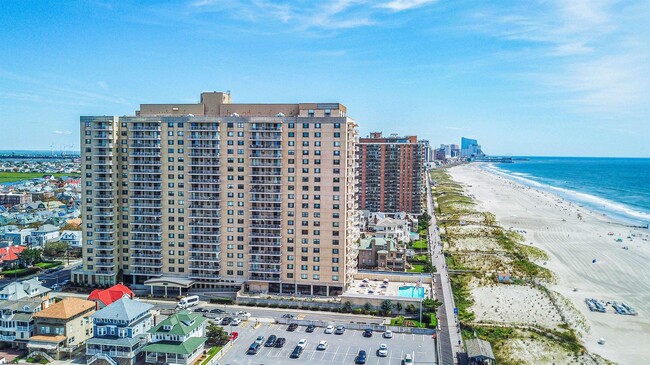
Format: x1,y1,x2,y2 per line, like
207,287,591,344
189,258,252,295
73,92,359,295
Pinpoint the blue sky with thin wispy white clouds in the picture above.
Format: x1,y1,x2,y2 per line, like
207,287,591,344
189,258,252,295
0,0,650,157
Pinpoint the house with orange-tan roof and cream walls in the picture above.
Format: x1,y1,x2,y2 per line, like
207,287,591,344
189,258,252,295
27,298,95,360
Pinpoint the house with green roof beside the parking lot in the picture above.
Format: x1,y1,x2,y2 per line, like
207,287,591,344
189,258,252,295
143,310,207,365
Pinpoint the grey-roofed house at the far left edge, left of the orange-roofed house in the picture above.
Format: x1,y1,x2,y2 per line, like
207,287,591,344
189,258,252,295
0,298,43,349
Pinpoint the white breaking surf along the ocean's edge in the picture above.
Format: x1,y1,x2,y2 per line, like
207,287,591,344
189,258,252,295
482,164,650,223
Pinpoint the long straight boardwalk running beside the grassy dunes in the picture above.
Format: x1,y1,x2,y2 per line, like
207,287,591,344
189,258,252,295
426,169,464,365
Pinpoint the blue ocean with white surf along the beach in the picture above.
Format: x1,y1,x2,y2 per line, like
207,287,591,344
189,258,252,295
483,157,650,225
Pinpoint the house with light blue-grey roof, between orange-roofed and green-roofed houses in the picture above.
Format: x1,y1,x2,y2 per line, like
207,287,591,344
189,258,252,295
86,298,153,365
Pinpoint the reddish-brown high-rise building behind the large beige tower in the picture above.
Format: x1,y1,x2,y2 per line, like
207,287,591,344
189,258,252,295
359,132,425,214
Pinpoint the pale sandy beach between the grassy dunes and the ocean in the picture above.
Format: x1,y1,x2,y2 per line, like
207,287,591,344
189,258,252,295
449,165,650,364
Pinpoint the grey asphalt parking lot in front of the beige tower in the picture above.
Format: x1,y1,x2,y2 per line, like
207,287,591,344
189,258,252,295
217,322,435,365
